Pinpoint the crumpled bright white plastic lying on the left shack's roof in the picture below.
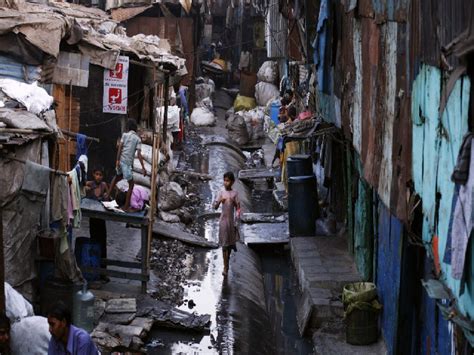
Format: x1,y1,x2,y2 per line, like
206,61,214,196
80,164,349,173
0,79,54,115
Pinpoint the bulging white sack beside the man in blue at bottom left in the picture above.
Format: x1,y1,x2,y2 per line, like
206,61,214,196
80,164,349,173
10,316,51,355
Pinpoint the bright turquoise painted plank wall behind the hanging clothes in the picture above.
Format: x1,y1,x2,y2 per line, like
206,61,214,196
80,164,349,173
412,65,474,328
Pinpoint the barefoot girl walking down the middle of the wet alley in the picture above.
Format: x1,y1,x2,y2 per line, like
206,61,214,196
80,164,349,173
214,171,240,276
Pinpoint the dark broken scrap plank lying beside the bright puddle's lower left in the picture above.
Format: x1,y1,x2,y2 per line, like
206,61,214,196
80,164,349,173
137,296,211,331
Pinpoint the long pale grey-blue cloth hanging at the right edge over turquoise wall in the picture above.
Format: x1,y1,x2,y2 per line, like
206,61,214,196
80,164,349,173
451,144,474,280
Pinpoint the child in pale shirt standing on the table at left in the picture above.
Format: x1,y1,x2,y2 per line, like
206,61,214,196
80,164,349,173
107,118,146,211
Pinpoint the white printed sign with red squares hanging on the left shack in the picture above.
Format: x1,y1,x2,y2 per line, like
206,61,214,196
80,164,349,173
103,56,129,115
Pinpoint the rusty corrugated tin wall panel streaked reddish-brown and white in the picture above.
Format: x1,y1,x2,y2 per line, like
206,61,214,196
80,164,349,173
339,9,411,221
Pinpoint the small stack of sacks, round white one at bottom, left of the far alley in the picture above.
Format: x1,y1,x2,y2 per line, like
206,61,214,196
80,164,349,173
191,77,216,126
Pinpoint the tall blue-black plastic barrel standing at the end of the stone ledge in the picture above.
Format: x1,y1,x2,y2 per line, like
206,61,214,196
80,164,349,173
288,175,319,237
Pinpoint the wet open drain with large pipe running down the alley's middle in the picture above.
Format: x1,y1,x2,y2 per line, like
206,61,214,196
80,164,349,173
148,141,312,354
